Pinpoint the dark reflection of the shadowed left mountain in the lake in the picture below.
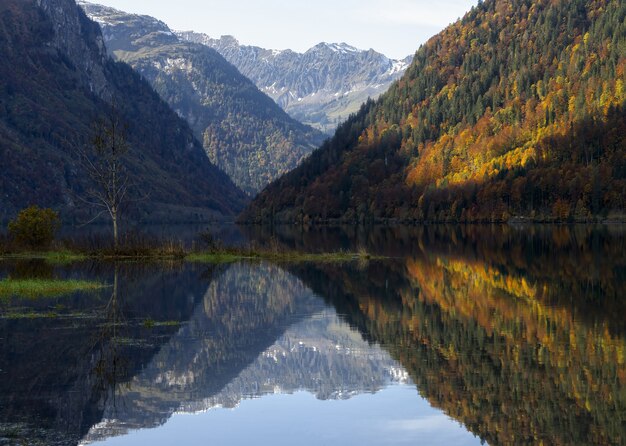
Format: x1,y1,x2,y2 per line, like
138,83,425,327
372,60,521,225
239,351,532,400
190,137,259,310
0,265,210,445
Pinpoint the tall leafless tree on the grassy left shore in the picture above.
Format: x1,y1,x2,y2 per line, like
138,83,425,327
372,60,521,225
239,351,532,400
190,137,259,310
79,107,132,249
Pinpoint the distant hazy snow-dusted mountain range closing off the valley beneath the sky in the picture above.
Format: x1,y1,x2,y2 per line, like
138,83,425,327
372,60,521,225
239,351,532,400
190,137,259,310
176,31,413,135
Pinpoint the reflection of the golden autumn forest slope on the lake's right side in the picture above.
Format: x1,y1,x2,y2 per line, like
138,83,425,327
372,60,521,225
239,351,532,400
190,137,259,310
289,228,626,445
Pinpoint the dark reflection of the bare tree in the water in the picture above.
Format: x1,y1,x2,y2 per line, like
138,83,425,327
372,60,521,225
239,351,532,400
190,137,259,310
92,264,128,409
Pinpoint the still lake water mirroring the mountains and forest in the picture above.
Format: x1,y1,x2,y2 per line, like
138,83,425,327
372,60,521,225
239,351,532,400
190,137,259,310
0,227,626,445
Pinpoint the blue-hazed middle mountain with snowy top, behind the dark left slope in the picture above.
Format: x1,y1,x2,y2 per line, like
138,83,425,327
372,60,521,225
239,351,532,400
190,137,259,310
80,2,325,194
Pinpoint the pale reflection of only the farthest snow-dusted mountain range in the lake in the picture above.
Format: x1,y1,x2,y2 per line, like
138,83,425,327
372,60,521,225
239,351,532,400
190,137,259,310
181,310,409,412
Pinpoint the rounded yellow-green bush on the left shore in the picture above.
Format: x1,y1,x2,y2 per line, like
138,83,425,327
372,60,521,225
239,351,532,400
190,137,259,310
9,206,59,249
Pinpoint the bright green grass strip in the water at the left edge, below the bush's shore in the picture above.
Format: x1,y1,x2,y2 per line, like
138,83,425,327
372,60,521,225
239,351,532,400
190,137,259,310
0,279,104,298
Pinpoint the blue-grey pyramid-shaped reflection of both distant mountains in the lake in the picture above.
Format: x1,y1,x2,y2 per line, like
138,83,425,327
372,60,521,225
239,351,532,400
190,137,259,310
84,264,407,443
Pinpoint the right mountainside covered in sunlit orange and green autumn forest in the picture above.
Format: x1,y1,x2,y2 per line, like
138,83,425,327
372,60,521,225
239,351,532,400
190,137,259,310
242,0,626,222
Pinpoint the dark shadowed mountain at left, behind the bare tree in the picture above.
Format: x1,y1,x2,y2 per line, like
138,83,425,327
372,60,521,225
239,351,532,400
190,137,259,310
0,0,246,221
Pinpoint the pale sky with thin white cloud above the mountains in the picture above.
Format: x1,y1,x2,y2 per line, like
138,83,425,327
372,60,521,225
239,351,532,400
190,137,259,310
89,0,477,58
